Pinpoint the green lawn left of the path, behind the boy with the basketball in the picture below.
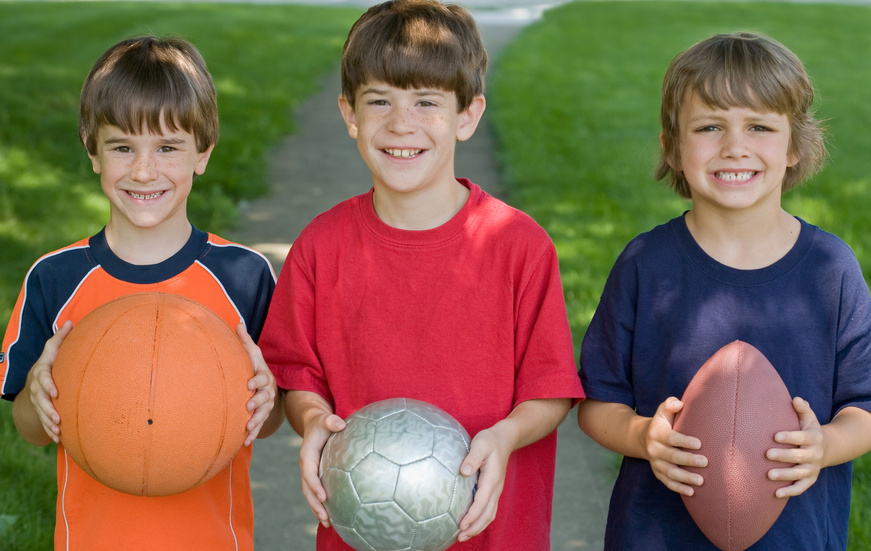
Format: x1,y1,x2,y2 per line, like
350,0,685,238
0,2,362,550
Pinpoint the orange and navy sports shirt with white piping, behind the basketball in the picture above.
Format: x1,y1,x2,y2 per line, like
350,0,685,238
0,228,275,550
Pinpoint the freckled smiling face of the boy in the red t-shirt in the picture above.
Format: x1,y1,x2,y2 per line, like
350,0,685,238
339,82,484,199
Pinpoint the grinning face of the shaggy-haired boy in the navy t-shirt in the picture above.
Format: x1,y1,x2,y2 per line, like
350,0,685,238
675,92,798,215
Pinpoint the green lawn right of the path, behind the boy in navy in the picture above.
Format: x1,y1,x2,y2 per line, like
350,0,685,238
488,2,871,550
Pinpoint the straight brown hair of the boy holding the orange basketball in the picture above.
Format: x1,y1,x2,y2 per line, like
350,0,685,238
79,36,218,155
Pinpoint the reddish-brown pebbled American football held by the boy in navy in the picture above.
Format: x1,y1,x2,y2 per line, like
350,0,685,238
674,341,800,551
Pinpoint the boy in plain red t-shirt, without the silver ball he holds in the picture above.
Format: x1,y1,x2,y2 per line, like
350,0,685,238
260,0,583,551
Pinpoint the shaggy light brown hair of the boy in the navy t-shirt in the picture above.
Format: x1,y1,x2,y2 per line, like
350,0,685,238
656,33,826,199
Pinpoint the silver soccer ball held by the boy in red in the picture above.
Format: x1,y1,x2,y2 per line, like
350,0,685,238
320,398,477,551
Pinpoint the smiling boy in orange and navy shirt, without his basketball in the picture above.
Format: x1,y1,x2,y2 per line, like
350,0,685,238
0,36,281,551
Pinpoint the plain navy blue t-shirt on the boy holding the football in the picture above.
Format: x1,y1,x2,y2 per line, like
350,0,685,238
580,217,871,551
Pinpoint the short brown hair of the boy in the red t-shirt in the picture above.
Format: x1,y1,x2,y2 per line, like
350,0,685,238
342,0,487,111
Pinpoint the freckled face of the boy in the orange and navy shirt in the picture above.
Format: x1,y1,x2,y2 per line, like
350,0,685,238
89,120,214,234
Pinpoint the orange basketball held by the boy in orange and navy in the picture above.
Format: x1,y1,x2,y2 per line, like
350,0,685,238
52,293,253,496
